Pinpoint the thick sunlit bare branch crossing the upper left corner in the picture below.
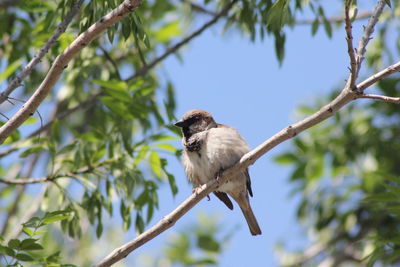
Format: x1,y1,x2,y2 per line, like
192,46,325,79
0,0,141,144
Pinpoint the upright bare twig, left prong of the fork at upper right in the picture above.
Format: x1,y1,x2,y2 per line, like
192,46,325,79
345,0,357,90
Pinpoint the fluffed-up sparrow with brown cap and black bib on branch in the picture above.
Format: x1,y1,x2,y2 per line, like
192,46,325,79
175,109,261,235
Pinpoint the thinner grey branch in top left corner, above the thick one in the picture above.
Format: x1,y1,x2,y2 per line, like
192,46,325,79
0,0,84,104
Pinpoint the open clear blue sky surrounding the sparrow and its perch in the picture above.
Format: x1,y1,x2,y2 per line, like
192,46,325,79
125,4,361,267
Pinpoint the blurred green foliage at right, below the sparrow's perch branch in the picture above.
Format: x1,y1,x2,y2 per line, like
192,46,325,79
275,78,400,266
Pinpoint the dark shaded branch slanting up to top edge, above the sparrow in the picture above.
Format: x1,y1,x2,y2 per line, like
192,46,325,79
126,0,237,81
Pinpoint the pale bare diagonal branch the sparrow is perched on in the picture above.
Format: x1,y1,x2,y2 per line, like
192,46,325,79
95,58,400,267
